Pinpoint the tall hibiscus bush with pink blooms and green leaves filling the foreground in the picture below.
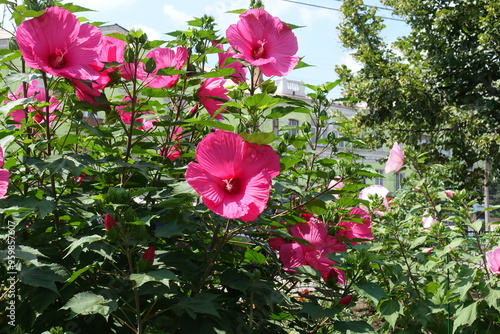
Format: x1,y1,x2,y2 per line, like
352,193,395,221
0,0,500,334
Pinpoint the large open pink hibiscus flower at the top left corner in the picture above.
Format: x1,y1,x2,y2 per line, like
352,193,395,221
16,7,103,80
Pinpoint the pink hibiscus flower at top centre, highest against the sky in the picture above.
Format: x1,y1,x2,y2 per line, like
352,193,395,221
226,8,299,77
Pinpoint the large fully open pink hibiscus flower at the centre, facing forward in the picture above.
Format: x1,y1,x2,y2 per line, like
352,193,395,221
186,130,280,221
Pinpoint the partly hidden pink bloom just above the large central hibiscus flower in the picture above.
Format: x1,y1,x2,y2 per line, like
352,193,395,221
198,77,229,119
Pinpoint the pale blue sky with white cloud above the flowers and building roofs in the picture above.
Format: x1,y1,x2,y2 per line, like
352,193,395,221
39,0,409,97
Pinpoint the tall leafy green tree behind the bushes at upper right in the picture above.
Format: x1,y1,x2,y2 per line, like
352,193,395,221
337,0,500,193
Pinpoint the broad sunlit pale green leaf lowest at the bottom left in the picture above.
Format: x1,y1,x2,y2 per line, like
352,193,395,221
61,291,118,318
